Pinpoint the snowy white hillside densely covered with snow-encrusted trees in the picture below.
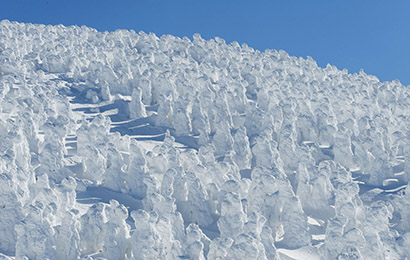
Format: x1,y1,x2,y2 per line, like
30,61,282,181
0,20,410,260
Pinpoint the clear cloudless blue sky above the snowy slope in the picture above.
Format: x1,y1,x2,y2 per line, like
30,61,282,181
0,0,410,85
